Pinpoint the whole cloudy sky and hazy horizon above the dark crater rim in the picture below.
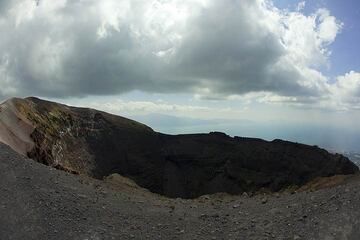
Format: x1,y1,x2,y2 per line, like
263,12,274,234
0,0,360,152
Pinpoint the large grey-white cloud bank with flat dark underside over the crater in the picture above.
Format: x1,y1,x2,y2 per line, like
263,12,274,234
0,0,354,109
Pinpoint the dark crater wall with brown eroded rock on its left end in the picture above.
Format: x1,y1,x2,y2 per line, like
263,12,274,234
0,98,358,198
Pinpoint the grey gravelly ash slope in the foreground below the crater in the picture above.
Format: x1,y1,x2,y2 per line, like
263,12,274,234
0,144,360,240
